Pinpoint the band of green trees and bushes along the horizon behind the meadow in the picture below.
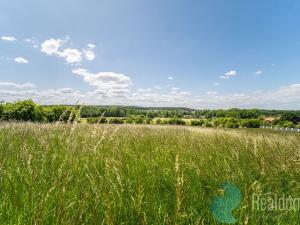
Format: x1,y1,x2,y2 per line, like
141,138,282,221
0,100,300,128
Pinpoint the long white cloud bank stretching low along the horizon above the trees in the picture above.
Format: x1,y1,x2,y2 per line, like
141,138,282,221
0,81,300,109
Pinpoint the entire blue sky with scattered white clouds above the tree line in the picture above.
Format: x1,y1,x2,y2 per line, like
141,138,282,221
0,0,300,109
